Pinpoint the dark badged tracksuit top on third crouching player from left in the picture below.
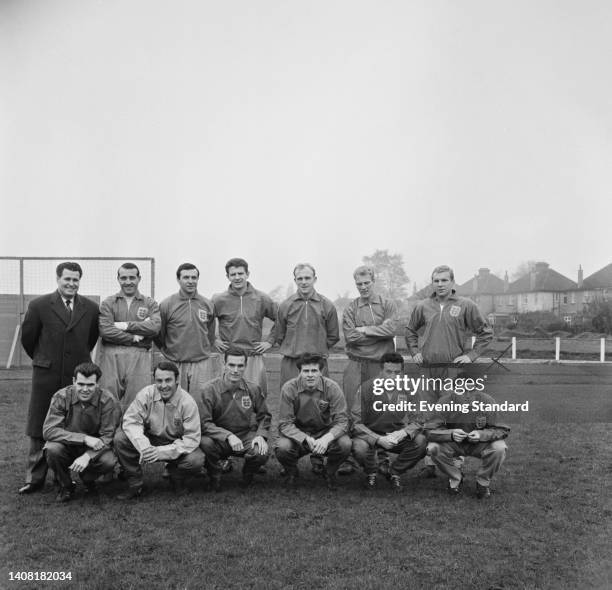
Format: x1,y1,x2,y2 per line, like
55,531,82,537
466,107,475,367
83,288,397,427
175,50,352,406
199,377,272,441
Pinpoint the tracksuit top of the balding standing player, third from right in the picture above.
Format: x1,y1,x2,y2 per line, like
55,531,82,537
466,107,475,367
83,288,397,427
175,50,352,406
276,291,340,359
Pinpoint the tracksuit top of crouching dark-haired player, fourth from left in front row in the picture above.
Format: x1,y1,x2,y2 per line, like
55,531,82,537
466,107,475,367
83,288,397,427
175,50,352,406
278,377,348,443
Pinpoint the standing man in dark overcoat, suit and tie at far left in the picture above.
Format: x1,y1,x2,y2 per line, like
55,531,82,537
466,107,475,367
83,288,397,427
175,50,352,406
19,262,99,494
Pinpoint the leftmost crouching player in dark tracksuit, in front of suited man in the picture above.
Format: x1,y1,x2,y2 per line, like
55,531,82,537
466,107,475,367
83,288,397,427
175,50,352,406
43,363,121,502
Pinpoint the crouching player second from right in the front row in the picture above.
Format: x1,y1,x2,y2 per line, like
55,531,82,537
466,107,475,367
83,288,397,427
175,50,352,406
352,352,427,492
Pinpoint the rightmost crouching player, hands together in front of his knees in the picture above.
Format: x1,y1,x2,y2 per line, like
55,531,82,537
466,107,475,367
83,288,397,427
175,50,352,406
425,384,510,499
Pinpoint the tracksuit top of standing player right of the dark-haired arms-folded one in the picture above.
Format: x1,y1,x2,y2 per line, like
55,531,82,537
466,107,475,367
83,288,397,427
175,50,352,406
155,291,215,363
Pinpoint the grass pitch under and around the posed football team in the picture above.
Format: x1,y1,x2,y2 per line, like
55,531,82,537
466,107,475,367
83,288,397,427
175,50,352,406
0,359,612,590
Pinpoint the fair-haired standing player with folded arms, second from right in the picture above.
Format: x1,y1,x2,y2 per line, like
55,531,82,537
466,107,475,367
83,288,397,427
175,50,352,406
339,266,397,475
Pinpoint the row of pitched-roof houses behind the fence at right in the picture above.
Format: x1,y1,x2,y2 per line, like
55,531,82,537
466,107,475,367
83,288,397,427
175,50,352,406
411,262,612,324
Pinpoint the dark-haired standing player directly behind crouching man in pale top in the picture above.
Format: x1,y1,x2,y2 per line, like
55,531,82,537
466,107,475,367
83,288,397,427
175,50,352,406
155,262,221,395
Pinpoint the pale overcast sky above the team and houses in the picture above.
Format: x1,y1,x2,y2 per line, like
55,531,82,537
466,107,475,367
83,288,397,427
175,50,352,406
0,0,612,299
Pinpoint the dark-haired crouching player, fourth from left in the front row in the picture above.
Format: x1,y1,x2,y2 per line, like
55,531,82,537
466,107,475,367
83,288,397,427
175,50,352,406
276,353,351,490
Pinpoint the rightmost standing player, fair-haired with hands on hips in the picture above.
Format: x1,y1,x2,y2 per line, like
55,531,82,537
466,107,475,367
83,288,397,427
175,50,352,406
406,265,493,477
